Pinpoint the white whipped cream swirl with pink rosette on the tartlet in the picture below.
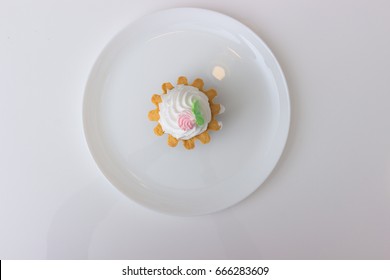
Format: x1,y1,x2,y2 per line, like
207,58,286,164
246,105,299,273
159,85,211,140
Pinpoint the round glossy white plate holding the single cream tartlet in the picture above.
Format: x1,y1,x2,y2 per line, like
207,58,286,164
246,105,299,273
83,8,290,215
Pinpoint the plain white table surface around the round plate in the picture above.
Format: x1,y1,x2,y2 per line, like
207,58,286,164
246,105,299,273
0,0,390,259
